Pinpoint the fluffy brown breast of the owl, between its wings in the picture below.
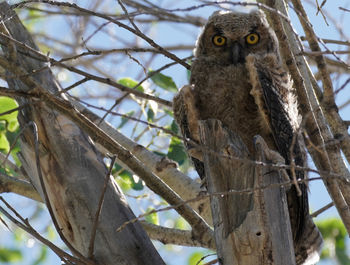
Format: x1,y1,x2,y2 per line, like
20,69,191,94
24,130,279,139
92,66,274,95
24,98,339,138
191,55,277,154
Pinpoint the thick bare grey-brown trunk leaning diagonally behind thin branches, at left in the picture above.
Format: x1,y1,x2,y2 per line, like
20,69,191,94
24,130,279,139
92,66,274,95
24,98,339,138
0,3,164,265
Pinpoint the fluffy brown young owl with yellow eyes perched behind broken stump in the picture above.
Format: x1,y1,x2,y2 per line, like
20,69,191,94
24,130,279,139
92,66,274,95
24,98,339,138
173,11,322,264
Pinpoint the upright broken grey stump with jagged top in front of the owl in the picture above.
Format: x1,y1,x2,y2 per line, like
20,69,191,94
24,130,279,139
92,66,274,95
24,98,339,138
200,120,295,265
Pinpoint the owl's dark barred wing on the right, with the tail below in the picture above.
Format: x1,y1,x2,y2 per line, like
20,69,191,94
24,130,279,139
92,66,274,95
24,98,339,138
248,54,322,264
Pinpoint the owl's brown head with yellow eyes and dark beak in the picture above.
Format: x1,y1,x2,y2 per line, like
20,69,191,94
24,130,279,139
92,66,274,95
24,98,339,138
195,11,278,64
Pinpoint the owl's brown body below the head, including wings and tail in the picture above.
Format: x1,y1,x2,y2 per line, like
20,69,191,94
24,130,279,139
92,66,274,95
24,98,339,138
174,53,322,264
